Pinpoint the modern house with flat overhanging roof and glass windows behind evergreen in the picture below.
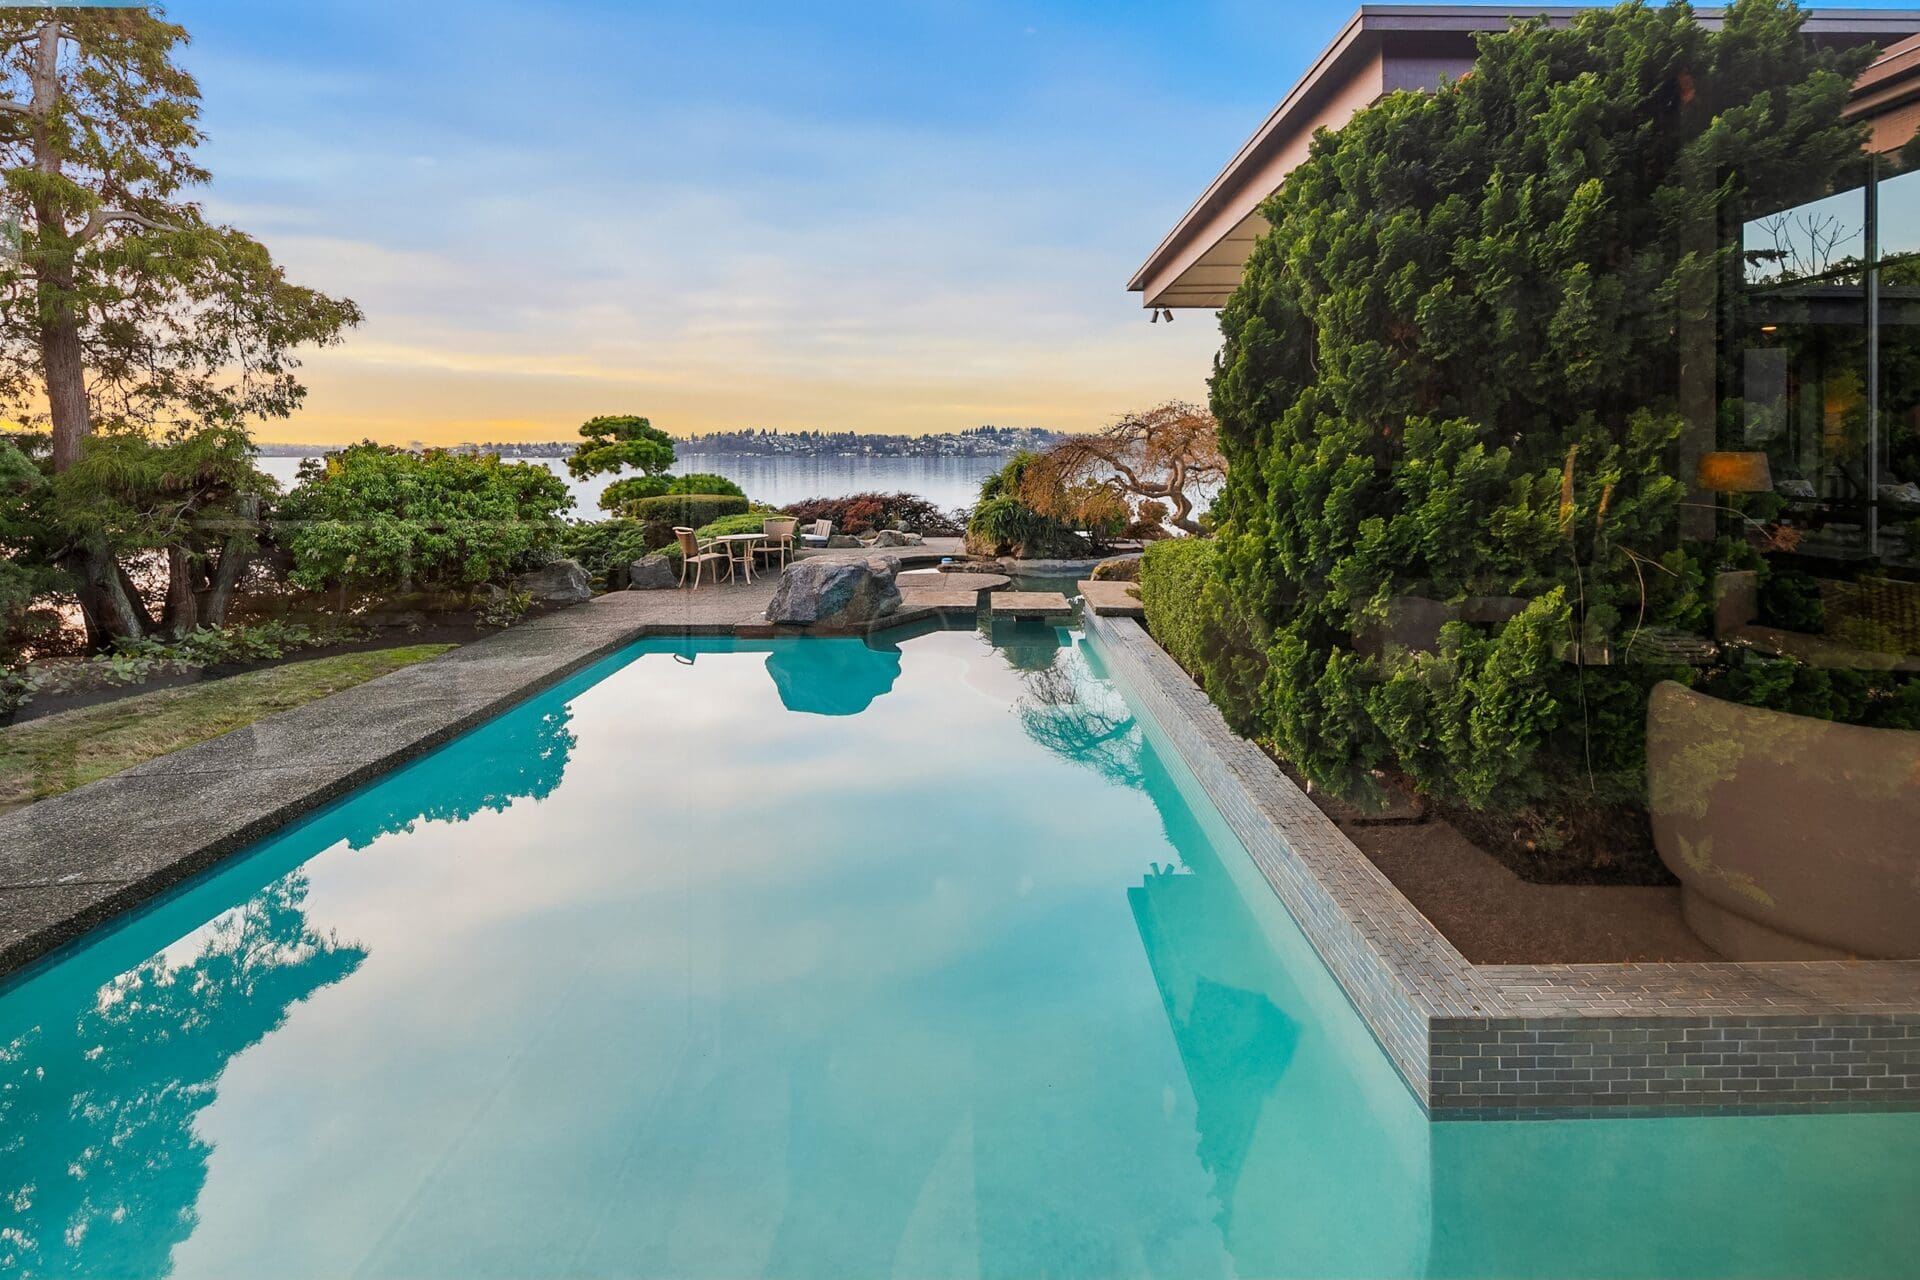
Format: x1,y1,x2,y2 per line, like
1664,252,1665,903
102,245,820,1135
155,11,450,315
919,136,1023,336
1127,4,1920,571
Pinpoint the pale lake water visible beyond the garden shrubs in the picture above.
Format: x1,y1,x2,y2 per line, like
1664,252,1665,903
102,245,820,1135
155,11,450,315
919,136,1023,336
259,453,1006,520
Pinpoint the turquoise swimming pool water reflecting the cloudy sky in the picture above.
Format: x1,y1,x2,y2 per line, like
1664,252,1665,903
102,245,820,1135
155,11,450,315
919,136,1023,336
0,629,1920,1278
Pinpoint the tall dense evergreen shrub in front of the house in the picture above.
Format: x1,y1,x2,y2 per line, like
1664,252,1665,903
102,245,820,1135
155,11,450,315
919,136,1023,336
1198,0,1866,832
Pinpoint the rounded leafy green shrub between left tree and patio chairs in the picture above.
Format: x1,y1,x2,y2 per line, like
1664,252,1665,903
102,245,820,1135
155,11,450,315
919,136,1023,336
278,443,572,589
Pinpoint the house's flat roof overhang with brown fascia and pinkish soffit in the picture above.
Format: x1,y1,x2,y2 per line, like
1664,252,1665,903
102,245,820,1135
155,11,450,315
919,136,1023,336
1127,4,1920,307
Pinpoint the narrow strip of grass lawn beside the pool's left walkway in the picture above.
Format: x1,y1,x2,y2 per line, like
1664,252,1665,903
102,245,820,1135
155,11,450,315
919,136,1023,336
0,645,453,814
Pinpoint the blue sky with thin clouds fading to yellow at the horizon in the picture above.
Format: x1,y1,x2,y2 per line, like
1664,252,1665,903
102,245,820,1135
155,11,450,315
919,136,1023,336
167,0,1374,443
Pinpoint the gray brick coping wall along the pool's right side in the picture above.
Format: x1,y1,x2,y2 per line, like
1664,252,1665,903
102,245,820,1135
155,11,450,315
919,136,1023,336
1085,614,1920,1119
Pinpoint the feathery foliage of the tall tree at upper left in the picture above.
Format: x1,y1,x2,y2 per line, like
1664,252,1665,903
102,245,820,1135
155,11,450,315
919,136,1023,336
0,8,361,434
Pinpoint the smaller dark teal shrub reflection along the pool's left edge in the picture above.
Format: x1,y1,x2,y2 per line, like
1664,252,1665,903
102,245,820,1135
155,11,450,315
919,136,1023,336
348,702,578,848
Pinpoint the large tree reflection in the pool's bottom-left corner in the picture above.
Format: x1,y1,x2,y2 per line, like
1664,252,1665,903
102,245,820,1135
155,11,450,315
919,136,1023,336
0,871,367,1276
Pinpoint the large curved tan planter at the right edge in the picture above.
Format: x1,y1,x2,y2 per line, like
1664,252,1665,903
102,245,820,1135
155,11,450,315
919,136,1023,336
1647,683,1920,960
